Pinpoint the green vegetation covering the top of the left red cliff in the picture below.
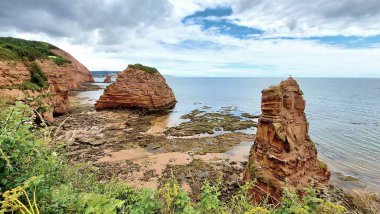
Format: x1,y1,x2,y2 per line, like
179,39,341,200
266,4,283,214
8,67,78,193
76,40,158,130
0,37,71,66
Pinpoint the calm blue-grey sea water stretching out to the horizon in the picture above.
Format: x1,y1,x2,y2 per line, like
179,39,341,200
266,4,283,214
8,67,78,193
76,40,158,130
79,77,380,192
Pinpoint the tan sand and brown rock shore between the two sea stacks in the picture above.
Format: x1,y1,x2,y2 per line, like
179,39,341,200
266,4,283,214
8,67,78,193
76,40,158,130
54,96,255,195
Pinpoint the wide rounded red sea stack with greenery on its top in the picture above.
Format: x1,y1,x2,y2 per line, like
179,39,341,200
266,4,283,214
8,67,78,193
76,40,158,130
95,64,177,110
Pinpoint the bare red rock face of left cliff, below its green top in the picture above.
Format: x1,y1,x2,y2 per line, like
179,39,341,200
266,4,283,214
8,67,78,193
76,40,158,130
0,49,94,122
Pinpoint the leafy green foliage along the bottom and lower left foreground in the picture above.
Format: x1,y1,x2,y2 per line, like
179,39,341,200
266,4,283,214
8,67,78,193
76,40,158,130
0,102,366,214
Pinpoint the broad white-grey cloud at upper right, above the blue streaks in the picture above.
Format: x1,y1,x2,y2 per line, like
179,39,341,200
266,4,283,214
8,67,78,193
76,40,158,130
231,0,380,37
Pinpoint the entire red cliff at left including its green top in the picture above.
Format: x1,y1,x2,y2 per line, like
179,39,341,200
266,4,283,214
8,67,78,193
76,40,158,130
0,38,94,121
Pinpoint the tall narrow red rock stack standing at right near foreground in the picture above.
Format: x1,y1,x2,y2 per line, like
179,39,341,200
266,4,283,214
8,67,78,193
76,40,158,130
244,78,330,203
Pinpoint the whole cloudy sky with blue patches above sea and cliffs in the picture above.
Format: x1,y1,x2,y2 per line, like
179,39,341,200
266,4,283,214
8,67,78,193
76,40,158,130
0,0,380,77
